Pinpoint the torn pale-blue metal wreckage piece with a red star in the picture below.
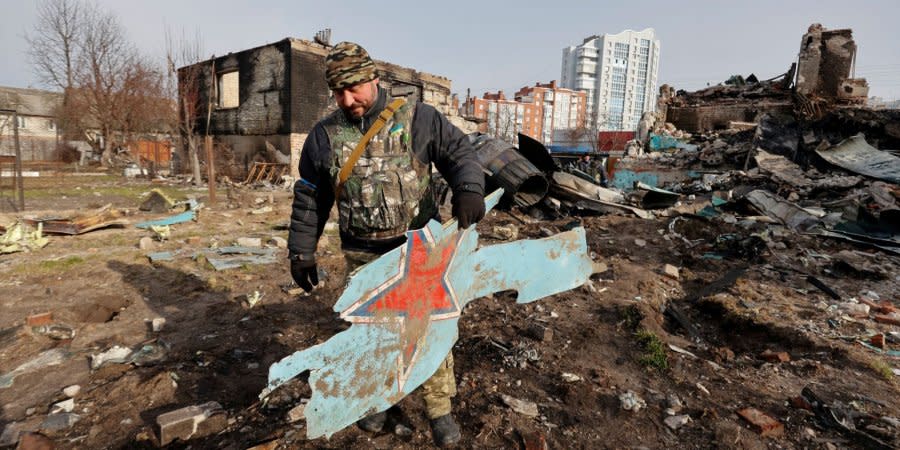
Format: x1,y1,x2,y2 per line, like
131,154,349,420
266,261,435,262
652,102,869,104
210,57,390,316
260,190,593,439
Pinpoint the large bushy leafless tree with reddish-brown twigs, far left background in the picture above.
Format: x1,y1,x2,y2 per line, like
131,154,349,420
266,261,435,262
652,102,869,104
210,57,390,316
26,0,175,165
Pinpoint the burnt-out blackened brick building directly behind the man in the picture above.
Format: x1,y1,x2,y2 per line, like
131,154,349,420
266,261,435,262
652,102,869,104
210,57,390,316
178,38,451,175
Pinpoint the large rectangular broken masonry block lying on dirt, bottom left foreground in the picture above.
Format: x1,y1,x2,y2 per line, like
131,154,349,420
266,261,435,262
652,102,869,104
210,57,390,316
156,402,228,446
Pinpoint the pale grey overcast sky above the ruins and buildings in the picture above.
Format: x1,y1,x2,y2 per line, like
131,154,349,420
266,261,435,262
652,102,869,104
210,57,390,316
0,0,900,99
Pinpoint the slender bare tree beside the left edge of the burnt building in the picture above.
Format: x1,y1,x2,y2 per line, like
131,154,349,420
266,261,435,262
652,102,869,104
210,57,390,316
165,28,203,184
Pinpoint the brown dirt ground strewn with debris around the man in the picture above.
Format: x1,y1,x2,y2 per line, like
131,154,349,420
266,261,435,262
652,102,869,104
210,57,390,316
0,175,900,449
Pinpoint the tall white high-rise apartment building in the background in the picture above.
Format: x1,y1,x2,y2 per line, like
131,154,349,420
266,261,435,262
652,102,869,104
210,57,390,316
560,28,659,131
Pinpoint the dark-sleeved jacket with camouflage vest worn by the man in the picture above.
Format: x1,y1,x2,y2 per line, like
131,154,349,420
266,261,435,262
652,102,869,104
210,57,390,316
288,88,484,259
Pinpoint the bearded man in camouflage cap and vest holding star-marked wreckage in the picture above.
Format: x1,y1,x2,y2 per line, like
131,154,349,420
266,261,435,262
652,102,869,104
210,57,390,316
288,42,484,446
